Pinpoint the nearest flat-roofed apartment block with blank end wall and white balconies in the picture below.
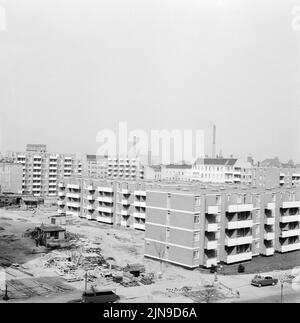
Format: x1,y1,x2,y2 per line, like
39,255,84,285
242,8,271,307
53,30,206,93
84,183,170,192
145,186,300,268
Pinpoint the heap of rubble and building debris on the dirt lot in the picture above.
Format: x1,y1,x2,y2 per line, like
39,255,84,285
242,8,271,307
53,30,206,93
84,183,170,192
42,235,154,287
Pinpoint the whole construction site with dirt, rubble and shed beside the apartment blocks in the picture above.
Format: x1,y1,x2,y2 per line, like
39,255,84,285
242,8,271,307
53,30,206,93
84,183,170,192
0,206,295,303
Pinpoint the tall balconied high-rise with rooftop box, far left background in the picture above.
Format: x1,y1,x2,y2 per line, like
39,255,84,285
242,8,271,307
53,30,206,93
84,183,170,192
9,144,82,196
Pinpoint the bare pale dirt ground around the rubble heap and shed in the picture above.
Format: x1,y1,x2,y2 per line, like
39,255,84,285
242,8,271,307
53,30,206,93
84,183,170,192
0,208,300,303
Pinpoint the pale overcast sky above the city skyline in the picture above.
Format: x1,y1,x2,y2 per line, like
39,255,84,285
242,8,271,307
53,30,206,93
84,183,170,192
0,0,300,162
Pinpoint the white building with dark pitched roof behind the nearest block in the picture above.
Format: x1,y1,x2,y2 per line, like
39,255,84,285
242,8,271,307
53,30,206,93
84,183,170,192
191,158,252,185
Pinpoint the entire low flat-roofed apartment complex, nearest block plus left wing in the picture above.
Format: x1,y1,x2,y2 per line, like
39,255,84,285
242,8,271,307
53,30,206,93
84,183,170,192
58,177,300,268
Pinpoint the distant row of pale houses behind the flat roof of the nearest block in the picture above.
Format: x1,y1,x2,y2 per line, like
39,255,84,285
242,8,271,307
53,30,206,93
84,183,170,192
144,158,300,187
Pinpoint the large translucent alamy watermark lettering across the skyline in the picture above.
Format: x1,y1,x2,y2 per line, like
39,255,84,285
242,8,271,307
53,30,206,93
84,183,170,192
96,122,204,164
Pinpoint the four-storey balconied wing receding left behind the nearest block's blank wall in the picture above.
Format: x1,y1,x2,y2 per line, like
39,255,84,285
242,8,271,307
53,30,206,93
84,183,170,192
57,177,152,230
